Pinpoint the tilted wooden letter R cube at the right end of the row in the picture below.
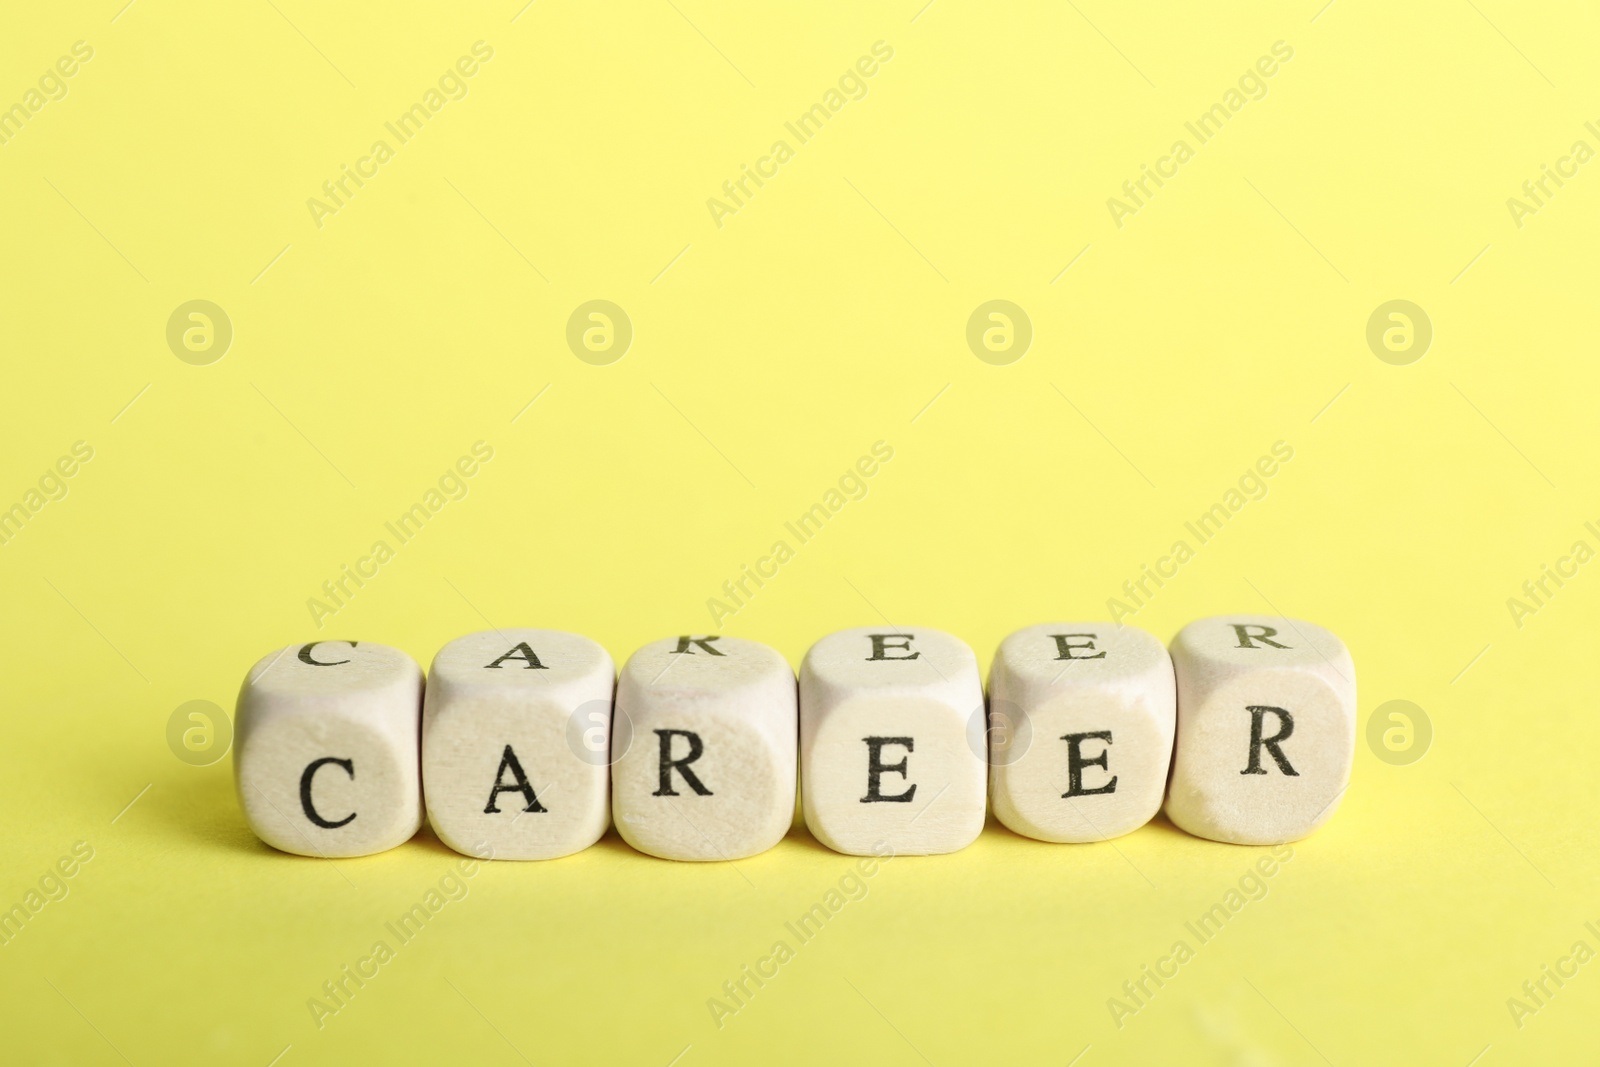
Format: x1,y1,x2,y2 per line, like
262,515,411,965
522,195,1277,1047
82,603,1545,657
1166,614,1355,845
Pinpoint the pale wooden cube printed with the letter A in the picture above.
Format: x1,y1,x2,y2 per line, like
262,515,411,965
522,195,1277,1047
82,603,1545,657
422,629,616,859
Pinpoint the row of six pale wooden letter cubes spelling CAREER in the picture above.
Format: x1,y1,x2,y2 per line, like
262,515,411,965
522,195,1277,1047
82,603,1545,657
235,616,1355,861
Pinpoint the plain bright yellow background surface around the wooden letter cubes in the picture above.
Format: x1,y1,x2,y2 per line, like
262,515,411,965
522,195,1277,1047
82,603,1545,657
0,0,1600,1067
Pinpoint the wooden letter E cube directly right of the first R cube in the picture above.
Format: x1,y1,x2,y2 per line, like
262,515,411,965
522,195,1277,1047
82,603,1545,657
800,627,987,856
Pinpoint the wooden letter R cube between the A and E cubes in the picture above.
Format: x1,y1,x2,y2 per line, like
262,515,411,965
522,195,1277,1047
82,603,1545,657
611,635,797,859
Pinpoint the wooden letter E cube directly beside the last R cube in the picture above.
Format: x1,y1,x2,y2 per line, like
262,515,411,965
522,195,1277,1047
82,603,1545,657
989,622,1178,841
